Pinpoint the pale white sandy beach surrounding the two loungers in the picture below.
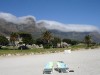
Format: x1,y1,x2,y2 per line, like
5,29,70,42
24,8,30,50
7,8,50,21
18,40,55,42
0,49,100,75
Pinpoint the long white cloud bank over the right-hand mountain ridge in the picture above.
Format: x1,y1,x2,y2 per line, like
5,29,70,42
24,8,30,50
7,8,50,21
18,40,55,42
37,20,99,32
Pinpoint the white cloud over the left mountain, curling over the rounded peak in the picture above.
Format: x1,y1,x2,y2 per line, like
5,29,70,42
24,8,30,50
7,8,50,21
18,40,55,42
0,12,36,23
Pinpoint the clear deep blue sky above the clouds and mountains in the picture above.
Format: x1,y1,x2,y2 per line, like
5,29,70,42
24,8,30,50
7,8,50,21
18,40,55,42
0,0,100,27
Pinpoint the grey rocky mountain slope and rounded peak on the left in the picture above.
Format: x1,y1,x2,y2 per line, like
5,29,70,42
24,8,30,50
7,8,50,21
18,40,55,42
0,17,41,36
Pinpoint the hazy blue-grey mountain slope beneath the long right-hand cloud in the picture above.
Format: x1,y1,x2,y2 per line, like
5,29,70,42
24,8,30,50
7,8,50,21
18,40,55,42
49,30,100,43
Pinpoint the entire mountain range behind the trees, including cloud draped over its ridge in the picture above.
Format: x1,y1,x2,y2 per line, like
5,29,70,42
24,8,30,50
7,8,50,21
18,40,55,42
0,13,100,43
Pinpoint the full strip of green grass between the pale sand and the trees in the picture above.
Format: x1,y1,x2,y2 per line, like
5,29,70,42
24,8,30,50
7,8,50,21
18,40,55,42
0,45,100,56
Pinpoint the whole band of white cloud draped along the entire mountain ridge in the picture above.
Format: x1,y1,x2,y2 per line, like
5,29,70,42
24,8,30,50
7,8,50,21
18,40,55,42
0,12,99,32
